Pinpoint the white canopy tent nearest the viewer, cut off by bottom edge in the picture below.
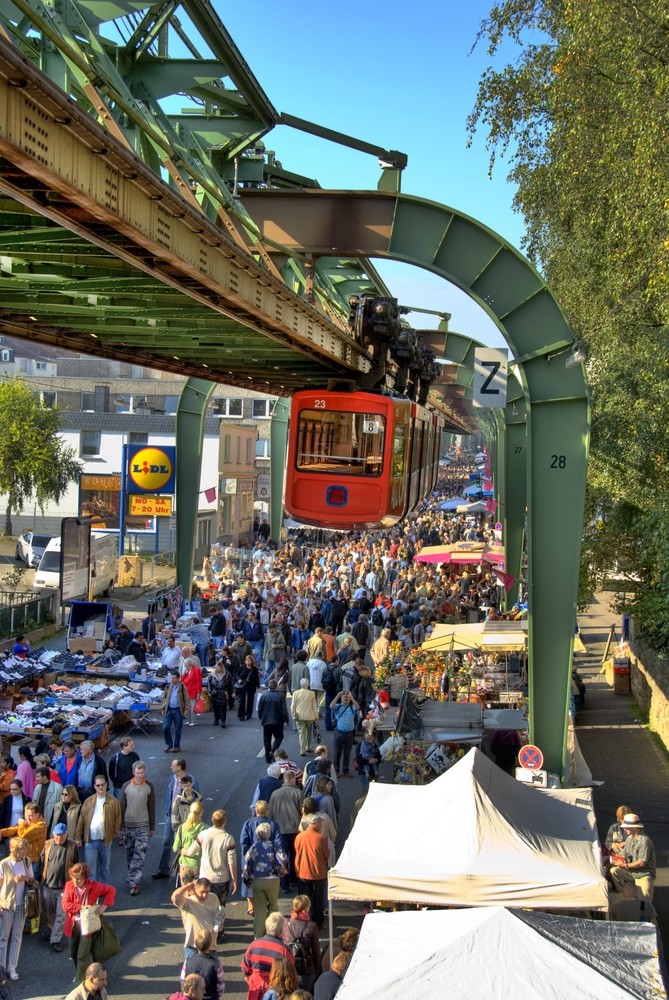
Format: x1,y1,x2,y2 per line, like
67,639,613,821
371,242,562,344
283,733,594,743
337,908,667,1000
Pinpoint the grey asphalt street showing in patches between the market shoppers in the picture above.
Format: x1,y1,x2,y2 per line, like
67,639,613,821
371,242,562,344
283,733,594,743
12,580,360,1000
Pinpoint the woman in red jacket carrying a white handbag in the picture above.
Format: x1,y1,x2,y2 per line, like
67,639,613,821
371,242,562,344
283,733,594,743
63,862,116,983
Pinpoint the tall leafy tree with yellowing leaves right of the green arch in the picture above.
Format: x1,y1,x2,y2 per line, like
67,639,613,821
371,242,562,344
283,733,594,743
468,0,669,649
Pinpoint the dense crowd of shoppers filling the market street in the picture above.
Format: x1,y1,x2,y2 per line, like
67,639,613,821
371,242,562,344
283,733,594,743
0,457,655,1000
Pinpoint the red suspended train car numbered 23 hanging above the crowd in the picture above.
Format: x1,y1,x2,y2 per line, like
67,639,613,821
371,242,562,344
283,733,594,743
285,389,443,531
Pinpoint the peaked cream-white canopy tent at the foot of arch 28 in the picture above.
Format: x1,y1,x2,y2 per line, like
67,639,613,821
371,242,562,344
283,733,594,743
329,748,608,910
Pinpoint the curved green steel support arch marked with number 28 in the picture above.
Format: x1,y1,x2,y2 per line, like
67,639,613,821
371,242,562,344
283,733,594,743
243,191,590,773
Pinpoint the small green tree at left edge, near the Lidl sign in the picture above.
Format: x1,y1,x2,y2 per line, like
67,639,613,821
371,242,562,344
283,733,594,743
0,378,83,535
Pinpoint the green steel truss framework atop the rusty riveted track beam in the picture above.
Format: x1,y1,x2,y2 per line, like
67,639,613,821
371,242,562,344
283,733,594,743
0,0,396,312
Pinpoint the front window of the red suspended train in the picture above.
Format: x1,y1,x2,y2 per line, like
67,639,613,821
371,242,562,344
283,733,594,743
295,410,386,476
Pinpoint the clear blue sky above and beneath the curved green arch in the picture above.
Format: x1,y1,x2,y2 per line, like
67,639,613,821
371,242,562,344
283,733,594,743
216,0,523,345
